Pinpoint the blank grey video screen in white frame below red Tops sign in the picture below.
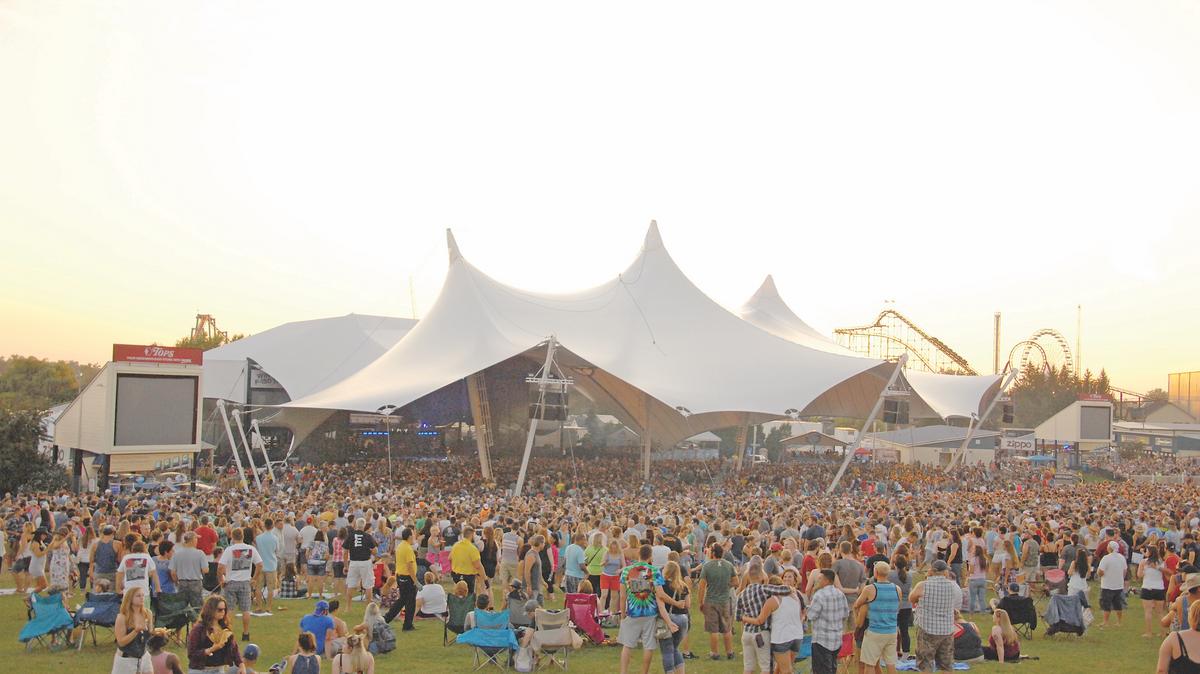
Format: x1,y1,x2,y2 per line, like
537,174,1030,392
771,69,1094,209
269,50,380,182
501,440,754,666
113,374,199,446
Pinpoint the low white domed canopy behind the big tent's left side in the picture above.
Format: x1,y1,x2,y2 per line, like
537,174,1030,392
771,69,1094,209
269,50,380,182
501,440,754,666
204,313,416,403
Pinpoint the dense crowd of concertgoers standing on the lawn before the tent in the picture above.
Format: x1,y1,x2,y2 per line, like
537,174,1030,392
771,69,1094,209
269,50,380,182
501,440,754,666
0,457,1200,674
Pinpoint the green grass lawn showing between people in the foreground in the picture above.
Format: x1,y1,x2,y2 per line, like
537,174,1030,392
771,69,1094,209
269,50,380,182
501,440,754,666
0,575,1160,674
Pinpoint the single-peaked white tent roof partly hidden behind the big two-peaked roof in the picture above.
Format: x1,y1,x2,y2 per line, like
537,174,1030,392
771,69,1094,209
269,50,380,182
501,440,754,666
738,275,1001,419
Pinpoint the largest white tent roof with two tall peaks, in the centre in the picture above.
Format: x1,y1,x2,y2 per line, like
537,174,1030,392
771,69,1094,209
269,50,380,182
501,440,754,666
287,223,893,443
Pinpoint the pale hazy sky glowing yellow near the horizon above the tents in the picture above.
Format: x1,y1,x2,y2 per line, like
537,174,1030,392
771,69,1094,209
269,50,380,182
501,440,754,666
0,0,1200,390
